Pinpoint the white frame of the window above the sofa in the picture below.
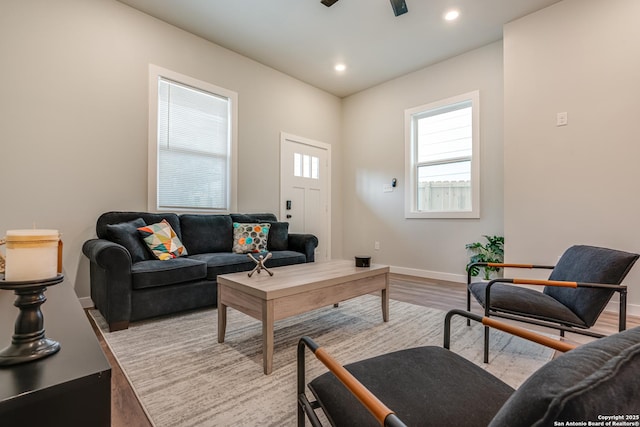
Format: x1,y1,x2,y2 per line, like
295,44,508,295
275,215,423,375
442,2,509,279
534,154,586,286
147,64,238,214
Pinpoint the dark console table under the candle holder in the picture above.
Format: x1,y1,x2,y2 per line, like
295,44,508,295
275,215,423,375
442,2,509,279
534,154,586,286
0,282,111,427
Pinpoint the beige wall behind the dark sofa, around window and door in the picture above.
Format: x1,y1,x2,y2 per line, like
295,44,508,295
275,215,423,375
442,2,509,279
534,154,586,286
0,0,341,297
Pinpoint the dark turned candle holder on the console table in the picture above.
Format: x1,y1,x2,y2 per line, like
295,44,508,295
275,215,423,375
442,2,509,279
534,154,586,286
0,274,64,366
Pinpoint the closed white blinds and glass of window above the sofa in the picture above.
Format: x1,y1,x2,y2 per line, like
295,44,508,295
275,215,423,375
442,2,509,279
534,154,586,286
157,77,231,211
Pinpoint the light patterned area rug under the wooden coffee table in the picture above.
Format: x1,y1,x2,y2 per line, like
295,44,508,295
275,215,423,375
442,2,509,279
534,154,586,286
91,295,553,427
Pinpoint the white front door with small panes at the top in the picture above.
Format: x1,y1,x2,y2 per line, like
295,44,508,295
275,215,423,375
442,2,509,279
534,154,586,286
280,133,331,261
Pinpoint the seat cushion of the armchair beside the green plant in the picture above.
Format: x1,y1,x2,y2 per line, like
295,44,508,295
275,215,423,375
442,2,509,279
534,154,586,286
469,282,588,328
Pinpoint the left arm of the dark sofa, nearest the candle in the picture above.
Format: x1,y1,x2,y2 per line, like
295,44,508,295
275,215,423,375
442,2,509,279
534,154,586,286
82,239,132,331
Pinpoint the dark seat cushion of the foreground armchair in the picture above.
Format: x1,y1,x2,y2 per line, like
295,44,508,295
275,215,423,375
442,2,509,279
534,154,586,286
309,347,514,427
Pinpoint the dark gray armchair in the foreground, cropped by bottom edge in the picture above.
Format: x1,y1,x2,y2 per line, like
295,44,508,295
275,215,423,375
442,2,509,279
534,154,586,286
297,310,640,427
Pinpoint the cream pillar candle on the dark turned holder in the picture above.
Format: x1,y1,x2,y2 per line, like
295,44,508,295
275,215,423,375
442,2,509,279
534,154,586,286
5,230,60,282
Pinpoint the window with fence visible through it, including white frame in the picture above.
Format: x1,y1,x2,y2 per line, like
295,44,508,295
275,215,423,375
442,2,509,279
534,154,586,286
406,92,479,218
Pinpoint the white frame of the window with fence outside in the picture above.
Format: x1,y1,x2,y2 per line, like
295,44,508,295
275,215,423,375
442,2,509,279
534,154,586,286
404,90,480,218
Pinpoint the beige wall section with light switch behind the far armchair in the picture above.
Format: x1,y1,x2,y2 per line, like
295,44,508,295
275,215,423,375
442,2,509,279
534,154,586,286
504,0,640,314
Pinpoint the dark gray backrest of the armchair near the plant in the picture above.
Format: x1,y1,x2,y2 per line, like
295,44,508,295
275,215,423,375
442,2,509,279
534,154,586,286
544,245,638,327
